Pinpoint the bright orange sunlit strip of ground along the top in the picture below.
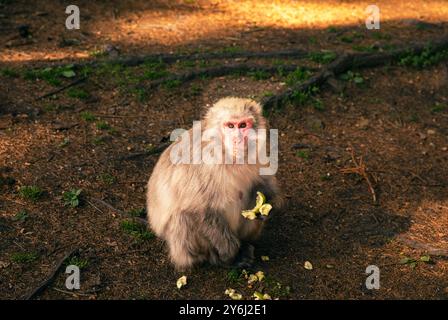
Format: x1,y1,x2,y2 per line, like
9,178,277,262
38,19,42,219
0,0,448,62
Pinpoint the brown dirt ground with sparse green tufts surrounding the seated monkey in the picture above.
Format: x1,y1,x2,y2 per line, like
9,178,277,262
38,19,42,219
0,0,448,299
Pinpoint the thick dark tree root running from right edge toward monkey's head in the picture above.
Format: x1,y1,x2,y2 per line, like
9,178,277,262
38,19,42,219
261,36,448,109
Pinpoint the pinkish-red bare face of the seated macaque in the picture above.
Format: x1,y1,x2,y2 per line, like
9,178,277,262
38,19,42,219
222,118,254,154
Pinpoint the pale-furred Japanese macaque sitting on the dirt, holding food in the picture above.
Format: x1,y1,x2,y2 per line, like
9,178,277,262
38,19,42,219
147,97,281,270
